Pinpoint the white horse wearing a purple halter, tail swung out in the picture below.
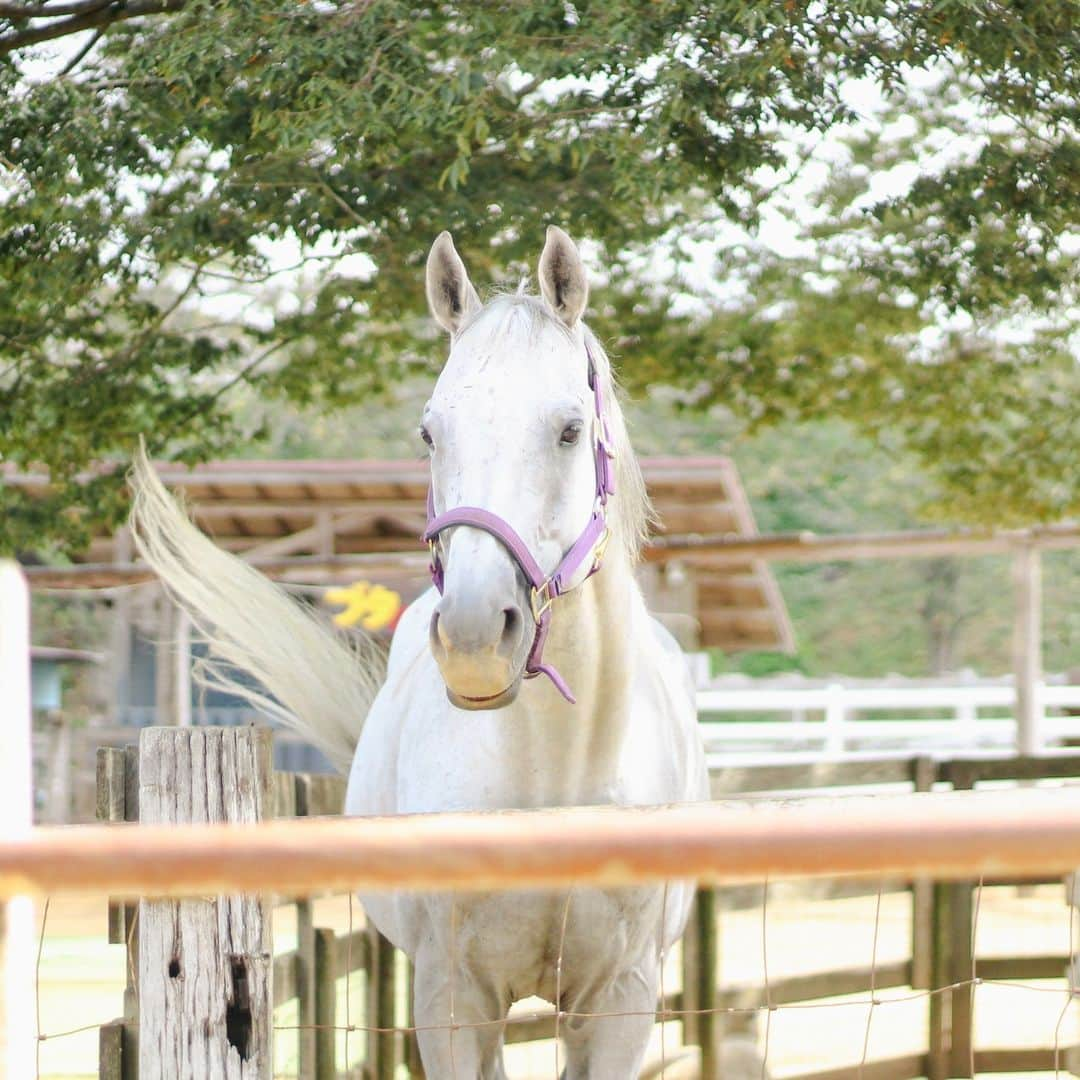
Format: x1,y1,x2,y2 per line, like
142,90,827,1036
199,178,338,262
133,228,708,1080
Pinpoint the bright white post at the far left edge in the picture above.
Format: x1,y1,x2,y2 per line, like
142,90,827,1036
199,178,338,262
0,561,36,1078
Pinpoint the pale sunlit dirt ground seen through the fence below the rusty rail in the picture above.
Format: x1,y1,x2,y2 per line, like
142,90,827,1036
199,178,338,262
29,885,1080,1080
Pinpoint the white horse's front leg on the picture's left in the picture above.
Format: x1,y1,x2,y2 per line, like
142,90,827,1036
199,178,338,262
413,956,510,1080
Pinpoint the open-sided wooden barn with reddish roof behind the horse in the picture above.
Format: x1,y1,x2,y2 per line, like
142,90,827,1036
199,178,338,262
12,457,793,743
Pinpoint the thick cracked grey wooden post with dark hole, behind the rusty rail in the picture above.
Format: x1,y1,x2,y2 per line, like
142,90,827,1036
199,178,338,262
138,728,273,1080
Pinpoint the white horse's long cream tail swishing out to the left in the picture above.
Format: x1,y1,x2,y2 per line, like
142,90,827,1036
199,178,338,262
129,446,386,772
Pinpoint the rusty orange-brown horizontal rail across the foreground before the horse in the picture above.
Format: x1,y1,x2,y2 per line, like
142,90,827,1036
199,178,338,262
10,781,1080,899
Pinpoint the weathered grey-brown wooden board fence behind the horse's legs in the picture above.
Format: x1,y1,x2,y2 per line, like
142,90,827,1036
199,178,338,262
88,729,1080,1080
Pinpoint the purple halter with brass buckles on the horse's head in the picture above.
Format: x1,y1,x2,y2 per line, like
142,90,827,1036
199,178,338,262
422,342,615,704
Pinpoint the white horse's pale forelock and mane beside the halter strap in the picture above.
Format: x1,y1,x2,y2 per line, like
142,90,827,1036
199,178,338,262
458,295,656,564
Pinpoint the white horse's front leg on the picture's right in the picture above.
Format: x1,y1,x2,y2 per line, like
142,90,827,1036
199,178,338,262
562,963,658,1080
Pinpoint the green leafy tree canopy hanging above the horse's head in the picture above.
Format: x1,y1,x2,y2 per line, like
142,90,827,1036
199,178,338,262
0,0,1080,549
